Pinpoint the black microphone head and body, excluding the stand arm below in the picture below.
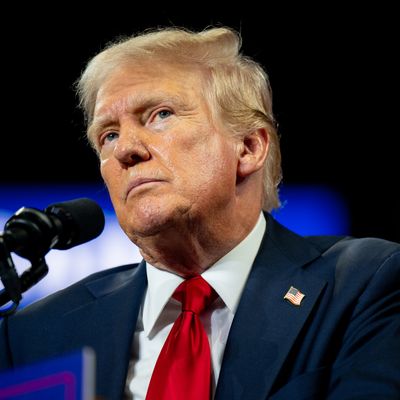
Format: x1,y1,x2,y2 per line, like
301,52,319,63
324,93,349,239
3,198,104,260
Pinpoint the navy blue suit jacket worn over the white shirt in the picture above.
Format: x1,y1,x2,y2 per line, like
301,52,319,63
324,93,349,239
0,216,400,400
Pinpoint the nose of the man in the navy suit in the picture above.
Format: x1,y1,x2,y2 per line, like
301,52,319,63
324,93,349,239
114,127,151,167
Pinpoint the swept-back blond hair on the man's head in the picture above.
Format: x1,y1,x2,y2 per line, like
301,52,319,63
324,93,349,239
77,28,281,211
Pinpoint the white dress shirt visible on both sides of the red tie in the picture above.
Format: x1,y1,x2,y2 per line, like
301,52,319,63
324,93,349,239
126,213,266,400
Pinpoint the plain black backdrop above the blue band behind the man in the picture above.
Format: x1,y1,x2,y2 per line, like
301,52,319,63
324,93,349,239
0,7,400,242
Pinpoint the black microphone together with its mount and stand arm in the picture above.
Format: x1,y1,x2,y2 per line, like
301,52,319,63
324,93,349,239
0,198,104,317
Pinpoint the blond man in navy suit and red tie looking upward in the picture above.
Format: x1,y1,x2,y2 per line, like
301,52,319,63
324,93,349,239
0,28,400,400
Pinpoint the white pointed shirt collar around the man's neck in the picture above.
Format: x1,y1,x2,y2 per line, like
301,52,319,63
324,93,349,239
143,213,266,336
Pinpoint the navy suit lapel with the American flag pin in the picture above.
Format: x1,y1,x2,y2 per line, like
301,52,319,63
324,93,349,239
215,216,326,400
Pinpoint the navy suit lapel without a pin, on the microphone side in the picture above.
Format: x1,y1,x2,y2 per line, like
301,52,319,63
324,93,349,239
64,262,147,399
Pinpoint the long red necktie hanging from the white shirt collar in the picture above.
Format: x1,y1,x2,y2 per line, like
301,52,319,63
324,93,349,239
146,276,217,400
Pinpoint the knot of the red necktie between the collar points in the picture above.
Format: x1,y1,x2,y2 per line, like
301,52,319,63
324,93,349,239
173,275,217,314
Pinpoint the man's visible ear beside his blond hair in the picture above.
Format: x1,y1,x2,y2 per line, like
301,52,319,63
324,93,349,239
237,128,269,178
